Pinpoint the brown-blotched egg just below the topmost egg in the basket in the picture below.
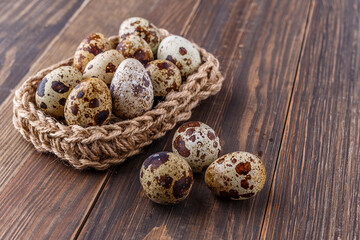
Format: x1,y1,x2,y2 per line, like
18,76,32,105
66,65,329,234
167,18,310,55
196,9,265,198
116,35,154,65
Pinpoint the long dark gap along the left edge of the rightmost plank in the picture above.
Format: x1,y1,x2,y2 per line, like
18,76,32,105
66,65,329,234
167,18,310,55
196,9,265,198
259,0,315,239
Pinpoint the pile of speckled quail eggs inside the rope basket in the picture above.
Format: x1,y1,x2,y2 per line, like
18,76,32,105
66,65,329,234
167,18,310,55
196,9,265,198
35,17,201,127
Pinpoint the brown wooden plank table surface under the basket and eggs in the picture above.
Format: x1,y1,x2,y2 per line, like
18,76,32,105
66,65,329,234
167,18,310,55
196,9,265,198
0,0,360,239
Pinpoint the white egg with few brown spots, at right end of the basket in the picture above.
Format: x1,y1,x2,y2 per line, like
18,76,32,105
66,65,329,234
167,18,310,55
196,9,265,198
157,35,201,77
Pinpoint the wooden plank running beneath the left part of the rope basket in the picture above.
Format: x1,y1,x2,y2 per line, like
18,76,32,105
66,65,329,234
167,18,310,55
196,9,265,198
0,0,198,239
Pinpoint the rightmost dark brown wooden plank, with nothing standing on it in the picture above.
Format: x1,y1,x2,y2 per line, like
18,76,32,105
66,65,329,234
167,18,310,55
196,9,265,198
261,0,360,239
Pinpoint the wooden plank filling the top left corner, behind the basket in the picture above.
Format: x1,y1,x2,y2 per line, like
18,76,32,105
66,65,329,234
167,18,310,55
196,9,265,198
0,0,86,103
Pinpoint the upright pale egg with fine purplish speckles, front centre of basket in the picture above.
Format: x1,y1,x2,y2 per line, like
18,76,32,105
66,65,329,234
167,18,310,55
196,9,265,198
110,58,154,118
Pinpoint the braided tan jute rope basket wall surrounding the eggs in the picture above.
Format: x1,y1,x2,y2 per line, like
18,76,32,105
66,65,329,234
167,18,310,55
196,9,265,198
13,29,224,170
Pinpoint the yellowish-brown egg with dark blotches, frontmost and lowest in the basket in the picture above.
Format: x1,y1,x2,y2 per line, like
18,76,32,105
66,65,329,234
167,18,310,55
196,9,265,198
65,78,111,127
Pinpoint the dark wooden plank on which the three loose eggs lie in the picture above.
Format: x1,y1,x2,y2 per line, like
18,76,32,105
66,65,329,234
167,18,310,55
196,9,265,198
80,0,310,239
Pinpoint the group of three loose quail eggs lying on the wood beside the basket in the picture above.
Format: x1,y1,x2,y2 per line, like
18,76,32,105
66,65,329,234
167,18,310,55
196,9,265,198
140,121,266,204
